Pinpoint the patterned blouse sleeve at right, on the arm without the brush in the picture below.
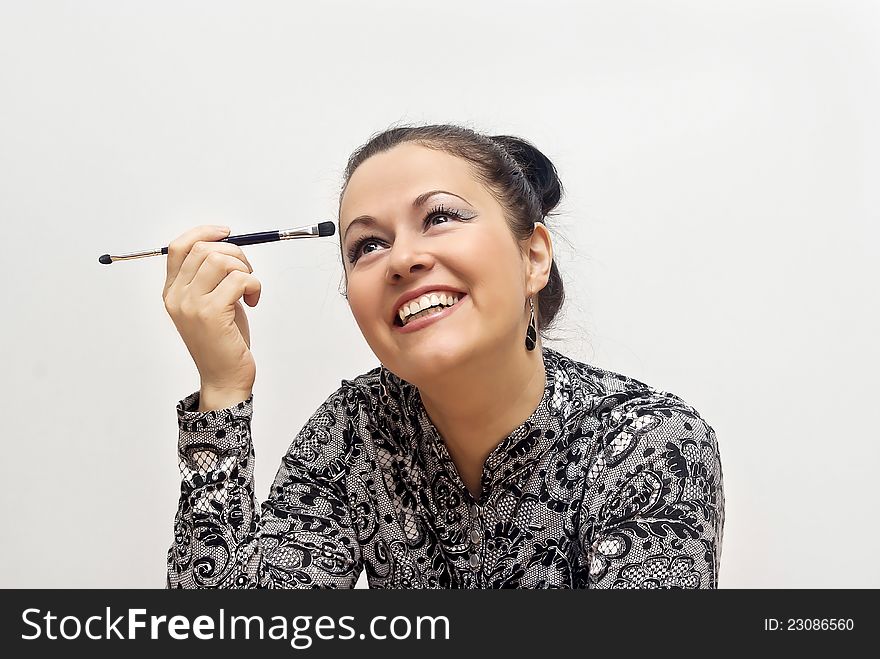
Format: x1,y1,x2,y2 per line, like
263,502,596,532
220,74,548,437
580,390,724,588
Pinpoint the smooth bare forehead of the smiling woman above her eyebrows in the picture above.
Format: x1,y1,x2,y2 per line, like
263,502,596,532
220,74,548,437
339,143,488,224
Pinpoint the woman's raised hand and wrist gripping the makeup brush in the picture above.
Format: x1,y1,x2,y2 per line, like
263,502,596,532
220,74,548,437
162,225,262,410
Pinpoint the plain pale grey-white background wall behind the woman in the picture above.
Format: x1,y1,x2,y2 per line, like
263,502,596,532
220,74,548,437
0,0,880,588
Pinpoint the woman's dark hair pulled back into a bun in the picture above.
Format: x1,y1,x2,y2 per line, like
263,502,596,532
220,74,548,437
339,124,565,332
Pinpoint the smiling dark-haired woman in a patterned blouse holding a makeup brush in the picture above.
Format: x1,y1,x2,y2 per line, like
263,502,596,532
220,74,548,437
163,125,724,588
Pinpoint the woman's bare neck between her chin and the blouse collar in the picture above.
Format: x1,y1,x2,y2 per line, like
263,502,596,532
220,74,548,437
419,342,546,492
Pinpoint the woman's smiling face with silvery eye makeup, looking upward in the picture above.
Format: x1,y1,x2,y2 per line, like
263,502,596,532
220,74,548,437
339,143,529,385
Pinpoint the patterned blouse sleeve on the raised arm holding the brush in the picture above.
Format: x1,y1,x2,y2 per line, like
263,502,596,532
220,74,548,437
166,387,362,588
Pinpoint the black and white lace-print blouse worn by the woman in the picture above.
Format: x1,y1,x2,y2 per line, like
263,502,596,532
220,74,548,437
166,347,724,588
